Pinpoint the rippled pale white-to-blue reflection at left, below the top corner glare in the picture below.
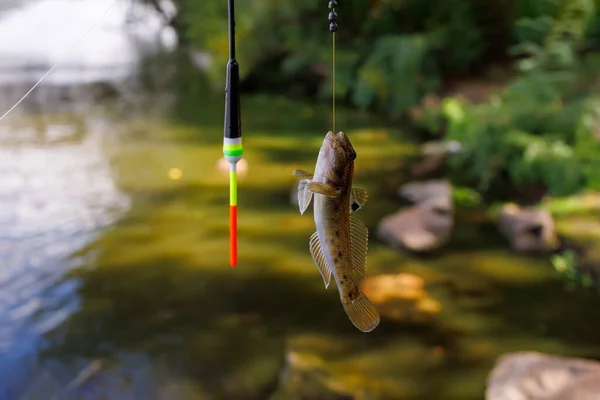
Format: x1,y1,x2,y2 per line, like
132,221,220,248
0,119,129,355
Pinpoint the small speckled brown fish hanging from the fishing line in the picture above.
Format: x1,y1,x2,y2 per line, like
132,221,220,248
293,131,379,332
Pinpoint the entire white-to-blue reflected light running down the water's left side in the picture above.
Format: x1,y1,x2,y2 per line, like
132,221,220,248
0,0,166,399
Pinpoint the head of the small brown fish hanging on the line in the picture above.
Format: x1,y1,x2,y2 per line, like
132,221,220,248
320,131,356,182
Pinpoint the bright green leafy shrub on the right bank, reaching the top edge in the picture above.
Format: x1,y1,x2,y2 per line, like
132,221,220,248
444,0,600,196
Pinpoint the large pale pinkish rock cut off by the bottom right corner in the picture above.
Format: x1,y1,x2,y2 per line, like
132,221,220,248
485,352,600,400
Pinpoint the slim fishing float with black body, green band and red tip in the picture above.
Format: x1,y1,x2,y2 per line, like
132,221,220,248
223,0,244,267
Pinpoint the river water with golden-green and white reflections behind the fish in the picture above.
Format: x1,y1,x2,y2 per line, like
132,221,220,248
0,0,600,400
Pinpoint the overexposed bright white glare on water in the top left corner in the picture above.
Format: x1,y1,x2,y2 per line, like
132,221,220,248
0,0,175,85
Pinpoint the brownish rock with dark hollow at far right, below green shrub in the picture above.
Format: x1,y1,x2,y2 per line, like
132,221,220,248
498,204,559,253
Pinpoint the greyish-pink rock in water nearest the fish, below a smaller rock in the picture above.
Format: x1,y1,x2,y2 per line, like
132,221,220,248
377,198,454,251
